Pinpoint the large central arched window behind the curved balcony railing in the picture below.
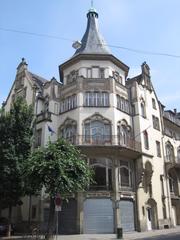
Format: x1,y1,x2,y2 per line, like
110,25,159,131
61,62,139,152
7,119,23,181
84,115,111,144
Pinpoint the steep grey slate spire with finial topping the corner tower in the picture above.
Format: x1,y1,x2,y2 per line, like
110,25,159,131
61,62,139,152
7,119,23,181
75,6,111,55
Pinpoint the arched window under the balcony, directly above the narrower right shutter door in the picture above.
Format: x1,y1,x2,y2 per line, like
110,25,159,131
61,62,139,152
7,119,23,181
118,160,133,189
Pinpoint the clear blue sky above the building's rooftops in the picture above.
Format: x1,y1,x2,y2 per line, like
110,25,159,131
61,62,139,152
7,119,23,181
0,0,180,111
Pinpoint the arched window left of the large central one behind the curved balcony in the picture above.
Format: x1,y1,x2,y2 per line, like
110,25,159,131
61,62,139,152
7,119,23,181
59,119,77,143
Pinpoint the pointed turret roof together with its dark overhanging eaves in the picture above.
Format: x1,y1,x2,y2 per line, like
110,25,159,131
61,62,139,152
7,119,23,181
59,7,129,85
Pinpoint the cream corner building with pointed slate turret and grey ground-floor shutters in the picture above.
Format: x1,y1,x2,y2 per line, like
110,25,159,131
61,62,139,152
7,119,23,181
1,8,180,234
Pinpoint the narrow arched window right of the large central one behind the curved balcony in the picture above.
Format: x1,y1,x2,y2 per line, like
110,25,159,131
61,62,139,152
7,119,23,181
117,120,131,146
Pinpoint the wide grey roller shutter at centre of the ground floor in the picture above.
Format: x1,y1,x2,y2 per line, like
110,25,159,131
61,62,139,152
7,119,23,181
84,199,114,233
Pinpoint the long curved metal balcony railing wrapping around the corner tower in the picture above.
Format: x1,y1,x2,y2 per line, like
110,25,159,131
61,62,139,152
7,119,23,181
62,135,141,151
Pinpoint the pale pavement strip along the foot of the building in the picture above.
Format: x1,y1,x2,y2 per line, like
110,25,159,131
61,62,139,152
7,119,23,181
0,226,180,240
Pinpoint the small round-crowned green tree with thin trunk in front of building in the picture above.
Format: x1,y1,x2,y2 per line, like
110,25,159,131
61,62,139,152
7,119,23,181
25,139,92,238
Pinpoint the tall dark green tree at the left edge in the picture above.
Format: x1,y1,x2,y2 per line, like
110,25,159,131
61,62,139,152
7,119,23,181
0,98,33,236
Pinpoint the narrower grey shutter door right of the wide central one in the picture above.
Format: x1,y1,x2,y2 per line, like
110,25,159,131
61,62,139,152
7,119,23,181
119,200,134,232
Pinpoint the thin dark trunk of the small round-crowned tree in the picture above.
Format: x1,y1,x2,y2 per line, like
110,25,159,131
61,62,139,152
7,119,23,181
45,198,55,240
